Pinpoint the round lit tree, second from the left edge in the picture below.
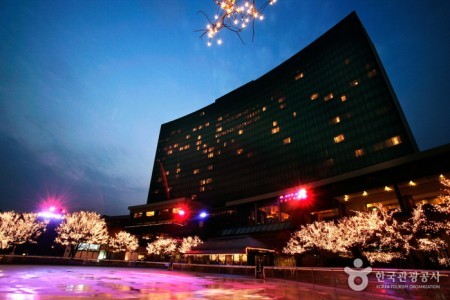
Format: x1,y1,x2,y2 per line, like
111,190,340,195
55,211,108,257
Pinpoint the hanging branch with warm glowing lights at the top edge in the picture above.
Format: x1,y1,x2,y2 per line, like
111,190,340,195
200,0,277,46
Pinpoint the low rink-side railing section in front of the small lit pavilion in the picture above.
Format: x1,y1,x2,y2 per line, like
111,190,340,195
172,263,256,276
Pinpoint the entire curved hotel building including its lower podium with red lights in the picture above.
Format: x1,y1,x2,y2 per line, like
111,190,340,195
129,13,449,260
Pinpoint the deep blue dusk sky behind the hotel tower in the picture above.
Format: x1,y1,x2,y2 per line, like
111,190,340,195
0,0,450,215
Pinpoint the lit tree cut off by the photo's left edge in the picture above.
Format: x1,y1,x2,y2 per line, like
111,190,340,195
0,211,46,254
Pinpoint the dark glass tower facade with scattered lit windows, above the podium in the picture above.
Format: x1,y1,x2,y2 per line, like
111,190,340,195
147,13,417,207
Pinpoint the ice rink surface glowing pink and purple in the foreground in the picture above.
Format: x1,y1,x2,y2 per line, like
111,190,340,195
0,265,412,300
